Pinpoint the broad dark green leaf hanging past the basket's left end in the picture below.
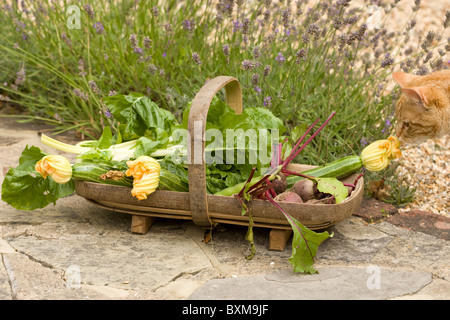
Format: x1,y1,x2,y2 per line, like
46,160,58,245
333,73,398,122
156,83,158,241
2,146,75,210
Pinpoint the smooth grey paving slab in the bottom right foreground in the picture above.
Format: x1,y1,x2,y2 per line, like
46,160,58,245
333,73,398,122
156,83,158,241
189,266,431,300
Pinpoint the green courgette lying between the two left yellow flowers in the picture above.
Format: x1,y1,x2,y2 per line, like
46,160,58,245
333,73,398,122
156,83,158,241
72,162,133,187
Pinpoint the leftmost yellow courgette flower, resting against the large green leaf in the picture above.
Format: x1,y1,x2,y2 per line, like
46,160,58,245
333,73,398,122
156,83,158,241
34,155,72,184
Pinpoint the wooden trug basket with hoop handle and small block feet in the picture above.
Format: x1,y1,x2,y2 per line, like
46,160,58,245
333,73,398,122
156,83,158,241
75,76,364,251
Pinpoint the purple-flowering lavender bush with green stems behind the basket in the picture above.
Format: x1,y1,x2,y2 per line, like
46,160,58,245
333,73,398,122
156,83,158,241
0,0,450,164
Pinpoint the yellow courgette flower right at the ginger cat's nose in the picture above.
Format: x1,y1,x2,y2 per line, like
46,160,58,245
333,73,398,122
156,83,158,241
361,136,402,171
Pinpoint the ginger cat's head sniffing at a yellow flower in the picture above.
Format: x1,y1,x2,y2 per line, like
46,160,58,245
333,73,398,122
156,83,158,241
392,70,450,144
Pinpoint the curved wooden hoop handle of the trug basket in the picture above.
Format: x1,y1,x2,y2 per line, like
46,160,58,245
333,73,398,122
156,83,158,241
188,76,242,227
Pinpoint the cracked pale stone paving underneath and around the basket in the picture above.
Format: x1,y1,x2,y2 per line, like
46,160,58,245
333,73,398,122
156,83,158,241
0,118,450,300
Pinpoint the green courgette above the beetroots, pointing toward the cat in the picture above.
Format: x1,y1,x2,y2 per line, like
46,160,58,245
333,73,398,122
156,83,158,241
286,156,363,188
